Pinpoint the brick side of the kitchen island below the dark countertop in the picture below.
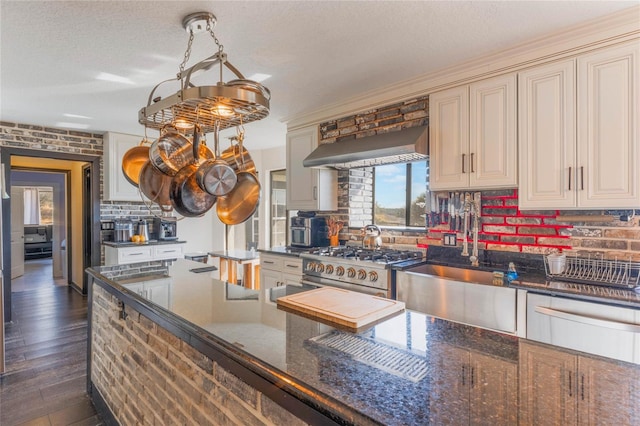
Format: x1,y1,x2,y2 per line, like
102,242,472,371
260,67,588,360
91,286,304,425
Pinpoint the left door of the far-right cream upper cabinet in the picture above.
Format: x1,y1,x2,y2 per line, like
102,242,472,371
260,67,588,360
518,60,576,210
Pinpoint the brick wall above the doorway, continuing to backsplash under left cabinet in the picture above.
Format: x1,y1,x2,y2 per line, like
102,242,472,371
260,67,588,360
0,121,160,220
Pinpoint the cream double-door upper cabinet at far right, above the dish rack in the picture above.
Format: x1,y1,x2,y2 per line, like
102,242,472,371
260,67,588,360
518,42,640,209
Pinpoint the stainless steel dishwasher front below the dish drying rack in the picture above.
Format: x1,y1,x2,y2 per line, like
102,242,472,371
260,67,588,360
527,293,640,364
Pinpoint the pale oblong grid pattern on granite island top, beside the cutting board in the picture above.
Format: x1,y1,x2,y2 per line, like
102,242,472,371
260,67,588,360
309,331,429,383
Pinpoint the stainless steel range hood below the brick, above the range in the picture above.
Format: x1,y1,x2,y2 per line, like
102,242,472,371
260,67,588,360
302,126,429,169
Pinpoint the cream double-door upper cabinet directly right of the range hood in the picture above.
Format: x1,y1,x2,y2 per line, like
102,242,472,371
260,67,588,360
429,74,517,190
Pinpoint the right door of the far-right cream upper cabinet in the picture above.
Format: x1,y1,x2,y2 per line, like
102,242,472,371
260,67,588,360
577,41,640,208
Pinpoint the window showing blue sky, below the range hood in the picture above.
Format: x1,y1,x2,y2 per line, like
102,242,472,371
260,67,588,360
373,161,427,227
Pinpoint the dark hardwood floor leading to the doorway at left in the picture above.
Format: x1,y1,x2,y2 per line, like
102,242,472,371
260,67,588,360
0,262,101,426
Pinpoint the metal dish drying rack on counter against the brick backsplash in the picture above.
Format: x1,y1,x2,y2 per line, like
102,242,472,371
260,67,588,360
544,256,640,289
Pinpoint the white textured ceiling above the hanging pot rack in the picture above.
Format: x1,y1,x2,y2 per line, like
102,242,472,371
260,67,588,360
0,0,638,149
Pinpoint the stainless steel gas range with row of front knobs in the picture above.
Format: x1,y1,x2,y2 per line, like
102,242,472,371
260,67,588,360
300,247,424,298
